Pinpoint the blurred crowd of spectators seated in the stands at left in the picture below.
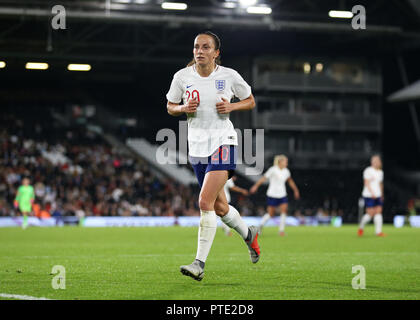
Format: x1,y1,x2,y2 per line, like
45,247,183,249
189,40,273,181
0,111,203,216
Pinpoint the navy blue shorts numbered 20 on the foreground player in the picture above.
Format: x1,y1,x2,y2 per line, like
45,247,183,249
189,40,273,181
189,145,237,188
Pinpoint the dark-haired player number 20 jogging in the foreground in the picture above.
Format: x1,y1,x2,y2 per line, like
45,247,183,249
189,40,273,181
166,31,260,281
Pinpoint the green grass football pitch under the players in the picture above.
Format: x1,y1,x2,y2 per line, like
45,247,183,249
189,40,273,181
0,225,420,300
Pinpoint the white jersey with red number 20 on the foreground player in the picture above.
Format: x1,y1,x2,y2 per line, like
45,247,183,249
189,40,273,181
166,65,251,157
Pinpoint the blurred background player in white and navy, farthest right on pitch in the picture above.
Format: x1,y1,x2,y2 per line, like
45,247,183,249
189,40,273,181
357,155,385,237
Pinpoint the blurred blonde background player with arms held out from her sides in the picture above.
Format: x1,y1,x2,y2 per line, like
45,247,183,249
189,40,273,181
250,155,300,236
